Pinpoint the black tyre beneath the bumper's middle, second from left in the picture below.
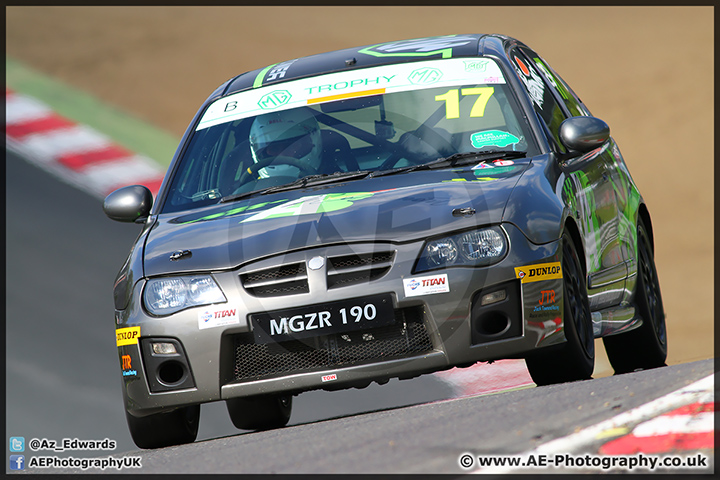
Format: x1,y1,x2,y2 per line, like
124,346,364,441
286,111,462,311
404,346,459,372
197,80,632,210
225,395,292,430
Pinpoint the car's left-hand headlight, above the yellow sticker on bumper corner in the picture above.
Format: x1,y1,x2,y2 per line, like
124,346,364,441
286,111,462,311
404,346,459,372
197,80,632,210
144,275,227,316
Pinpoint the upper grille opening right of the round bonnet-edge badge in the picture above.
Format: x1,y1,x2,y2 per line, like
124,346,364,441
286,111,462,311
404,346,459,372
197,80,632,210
327,252,395,289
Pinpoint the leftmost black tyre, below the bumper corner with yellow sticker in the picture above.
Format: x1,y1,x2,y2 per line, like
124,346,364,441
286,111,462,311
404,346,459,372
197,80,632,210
125,405,200,448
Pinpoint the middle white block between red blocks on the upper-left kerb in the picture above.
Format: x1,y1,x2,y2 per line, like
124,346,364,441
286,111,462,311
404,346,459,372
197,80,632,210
21,125,112,161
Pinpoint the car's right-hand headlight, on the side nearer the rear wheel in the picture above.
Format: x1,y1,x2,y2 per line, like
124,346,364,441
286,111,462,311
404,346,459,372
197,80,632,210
415,227,508,272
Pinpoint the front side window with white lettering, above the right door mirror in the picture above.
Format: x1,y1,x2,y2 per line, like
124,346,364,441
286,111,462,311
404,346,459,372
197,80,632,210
510,49,567,153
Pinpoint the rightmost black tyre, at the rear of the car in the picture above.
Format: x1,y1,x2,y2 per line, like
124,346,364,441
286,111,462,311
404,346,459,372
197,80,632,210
603,220,667,374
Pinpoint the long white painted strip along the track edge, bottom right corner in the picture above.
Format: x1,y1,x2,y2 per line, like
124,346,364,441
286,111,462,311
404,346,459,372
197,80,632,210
469,374,715,474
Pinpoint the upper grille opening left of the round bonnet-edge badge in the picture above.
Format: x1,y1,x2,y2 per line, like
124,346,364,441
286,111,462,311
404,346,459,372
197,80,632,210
240,262,310,297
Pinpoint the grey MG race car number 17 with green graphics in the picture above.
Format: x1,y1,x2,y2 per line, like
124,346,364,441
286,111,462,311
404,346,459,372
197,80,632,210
104,35,667,448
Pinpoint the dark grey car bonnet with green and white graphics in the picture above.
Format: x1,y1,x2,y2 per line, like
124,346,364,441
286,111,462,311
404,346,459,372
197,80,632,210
144,167,527,276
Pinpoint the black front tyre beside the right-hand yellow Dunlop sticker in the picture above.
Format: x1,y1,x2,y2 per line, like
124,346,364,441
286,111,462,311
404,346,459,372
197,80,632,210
525,231,595,386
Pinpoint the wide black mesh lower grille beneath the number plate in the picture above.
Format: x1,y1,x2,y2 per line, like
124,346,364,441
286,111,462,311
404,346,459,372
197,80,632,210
234,307,433,381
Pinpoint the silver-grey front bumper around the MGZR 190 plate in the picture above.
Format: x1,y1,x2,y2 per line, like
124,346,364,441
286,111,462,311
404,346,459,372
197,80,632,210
116,224,564,416
